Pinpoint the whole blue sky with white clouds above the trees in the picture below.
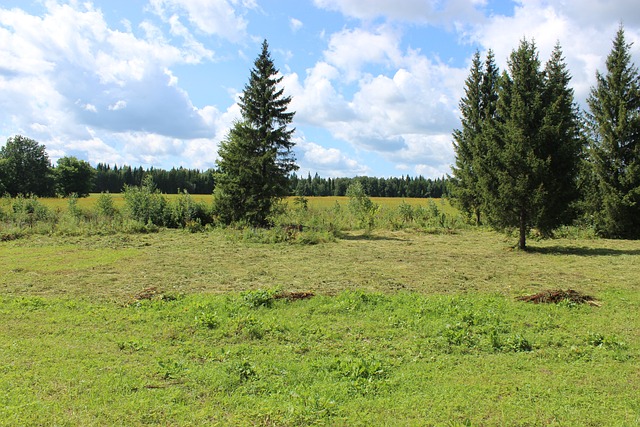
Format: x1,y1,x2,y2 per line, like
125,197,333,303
0,0,640,178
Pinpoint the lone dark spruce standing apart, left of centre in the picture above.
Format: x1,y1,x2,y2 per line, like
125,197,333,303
214,40,298,226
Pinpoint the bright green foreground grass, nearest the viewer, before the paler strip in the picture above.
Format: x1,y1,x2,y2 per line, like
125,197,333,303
0,291,640,426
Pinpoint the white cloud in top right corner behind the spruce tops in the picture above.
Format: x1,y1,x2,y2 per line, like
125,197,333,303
464,0,640,103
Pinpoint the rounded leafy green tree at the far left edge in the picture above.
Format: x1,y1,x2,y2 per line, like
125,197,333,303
0,135,53,196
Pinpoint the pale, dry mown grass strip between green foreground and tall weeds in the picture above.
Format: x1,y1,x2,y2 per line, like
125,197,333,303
0,230,640,299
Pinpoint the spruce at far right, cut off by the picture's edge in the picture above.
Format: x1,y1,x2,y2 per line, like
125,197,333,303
587,25,640,238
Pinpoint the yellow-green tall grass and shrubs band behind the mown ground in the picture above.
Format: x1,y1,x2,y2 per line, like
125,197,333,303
0,191,466,243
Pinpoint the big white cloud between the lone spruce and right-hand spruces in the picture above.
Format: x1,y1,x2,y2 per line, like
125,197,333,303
283,27,467,176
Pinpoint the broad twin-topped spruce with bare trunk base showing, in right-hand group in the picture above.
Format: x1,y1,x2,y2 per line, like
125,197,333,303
477,40,580,249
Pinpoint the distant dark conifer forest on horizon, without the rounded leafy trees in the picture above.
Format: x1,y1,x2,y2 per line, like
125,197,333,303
92,163,448,198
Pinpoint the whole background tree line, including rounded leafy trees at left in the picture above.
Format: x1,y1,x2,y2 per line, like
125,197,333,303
0,139,449,198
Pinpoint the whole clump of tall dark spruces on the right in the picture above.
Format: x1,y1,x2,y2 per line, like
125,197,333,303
452,27,640,249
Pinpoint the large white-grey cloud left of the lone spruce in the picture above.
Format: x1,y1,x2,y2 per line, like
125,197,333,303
0,1,229,166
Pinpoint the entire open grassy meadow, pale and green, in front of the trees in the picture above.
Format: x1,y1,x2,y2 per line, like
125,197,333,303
0,195,640,426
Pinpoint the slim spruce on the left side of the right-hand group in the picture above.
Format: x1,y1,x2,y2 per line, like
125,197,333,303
452,50,499,224
